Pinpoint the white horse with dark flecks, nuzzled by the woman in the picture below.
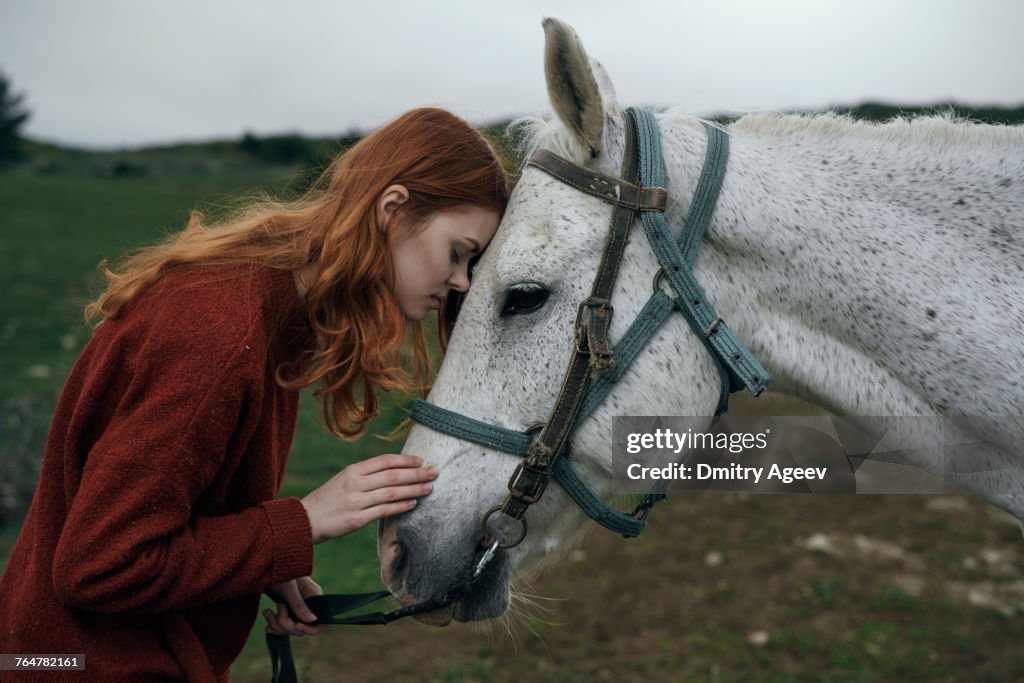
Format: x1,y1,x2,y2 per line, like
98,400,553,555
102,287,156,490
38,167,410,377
379,19,1024,623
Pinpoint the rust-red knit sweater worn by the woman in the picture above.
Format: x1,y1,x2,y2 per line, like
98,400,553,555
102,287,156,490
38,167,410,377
0,267,313,683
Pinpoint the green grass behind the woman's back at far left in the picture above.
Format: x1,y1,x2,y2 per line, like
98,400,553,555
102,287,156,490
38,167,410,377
0,162,299,398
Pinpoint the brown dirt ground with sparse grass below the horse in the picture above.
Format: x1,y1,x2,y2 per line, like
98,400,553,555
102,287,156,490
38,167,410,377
232,495,1024,683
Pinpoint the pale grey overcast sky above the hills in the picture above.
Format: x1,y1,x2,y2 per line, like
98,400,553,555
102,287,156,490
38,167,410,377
0,0,1024,147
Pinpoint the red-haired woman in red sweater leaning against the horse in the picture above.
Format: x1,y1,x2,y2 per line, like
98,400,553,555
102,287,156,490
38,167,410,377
0,109,508,681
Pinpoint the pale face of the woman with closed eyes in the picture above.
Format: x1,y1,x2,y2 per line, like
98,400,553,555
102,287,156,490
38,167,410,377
391,207,501,321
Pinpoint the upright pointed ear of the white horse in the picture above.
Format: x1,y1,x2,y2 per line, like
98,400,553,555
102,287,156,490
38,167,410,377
543,17,618,158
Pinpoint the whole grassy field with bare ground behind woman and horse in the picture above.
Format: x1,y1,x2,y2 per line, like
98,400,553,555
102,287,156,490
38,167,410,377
0,120,1024,683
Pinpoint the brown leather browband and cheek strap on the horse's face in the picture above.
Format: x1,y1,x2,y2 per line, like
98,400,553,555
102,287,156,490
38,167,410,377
481,112,651,548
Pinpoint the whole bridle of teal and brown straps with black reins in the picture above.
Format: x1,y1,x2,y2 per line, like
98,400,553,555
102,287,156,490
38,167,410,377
267,108,770,683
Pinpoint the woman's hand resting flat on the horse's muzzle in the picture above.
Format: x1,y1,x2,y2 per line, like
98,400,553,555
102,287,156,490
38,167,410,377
302,455,437,543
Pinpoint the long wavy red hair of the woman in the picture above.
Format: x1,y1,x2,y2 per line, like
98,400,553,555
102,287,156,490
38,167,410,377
85,109,509,437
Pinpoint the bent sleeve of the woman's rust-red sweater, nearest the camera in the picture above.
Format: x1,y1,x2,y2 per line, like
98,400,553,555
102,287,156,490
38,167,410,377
53,280,312,613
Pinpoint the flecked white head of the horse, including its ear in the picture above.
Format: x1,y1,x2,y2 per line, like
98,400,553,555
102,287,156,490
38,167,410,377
379,18,720,623
